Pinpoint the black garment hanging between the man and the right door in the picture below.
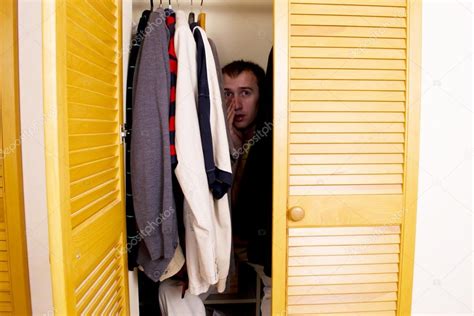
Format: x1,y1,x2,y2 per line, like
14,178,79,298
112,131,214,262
232,49,273,276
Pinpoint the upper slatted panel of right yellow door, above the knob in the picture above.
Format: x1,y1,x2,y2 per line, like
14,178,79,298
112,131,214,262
289,1,406,195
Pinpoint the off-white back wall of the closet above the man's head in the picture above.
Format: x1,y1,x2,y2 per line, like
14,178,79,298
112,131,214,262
133,0,273,69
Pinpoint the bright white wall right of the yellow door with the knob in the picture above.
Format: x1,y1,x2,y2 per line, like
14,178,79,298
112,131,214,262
412,0,473,315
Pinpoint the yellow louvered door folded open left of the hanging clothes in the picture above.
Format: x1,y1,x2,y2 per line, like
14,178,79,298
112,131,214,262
43,0,129,315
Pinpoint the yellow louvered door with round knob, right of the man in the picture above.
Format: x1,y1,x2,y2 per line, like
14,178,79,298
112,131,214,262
272,0,421,316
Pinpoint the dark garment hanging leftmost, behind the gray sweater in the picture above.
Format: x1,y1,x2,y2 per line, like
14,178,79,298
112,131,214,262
125,10,150,271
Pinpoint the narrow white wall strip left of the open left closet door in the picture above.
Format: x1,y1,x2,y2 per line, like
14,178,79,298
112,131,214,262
18,0,53,315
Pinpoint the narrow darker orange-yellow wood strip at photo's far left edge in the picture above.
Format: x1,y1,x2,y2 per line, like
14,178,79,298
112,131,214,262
0,0,32,315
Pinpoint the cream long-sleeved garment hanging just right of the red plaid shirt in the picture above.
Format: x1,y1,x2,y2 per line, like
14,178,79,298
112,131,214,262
175,11,231,295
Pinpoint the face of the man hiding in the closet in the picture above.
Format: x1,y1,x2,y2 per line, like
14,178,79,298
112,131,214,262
224,71,259,130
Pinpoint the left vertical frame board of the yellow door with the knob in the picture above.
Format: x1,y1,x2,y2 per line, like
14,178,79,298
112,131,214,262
271,0,290,315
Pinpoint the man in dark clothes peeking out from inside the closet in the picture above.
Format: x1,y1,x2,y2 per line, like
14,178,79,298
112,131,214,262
222,60,272,315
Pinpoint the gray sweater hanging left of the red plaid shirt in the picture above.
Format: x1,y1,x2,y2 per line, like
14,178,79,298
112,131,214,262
131,9,178,282
